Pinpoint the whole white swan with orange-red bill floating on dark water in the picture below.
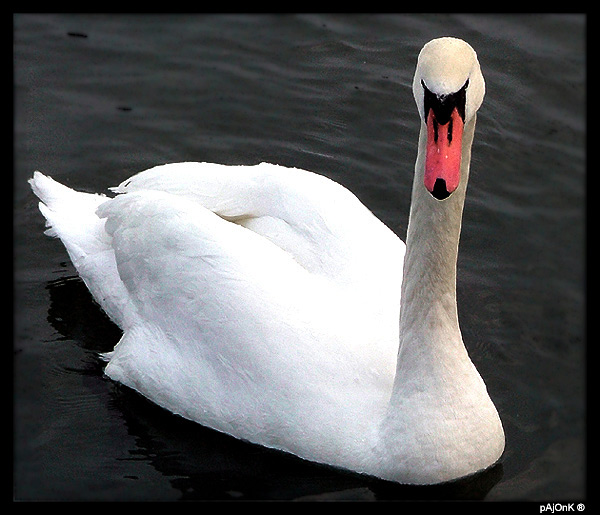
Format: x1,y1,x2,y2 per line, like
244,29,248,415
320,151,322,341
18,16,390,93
29,37,505,484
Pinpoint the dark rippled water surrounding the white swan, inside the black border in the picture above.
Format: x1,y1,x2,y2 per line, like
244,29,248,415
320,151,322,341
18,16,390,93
13,15,586,502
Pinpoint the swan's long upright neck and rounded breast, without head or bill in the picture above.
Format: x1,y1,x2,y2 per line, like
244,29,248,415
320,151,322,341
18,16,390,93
372,117,504,483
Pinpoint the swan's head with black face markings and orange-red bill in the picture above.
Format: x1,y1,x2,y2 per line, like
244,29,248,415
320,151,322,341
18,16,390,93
413,38,485,200
